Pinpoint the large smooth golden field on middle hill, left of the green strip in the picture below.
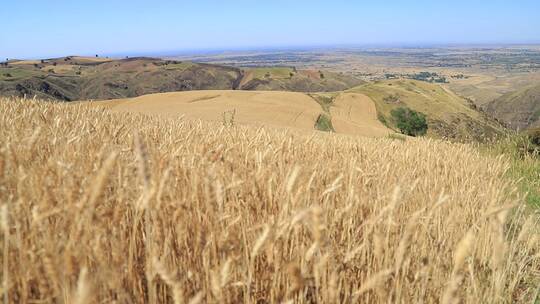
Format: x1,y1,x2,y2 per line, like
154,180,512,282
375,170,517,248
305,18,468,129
92,90,321,131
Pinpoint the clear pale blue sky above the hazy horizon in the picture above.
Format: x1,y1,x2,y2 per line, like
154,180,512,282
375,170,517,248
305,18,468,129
0,0,540,58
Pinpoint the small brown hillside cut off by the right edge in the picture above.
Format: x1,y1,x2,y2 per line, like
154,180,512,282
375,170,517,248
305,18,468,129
486,85,540,130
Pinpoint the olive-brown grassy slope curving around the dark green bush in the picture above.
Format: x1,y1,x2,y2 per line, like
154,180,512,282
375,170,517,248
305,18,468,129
349,80,504,141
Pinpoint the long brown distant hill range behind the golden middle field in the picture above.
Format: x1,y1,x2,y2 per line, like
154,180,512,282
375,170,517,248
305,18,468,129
0,56,362,101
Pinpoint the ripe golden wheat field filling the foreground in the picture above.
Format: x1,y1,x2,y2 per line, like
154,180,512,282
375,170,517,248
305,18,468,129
0,99,540,304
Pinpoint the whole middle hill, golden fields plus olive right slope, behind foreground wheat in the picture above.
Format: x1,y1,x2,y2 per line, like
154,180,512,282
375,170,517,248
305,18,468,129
86,80,504,141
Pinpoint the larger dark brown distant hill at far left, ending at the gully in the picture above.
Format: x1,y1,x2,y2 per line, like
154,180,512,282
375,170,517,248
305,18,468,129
0,57,242,101
